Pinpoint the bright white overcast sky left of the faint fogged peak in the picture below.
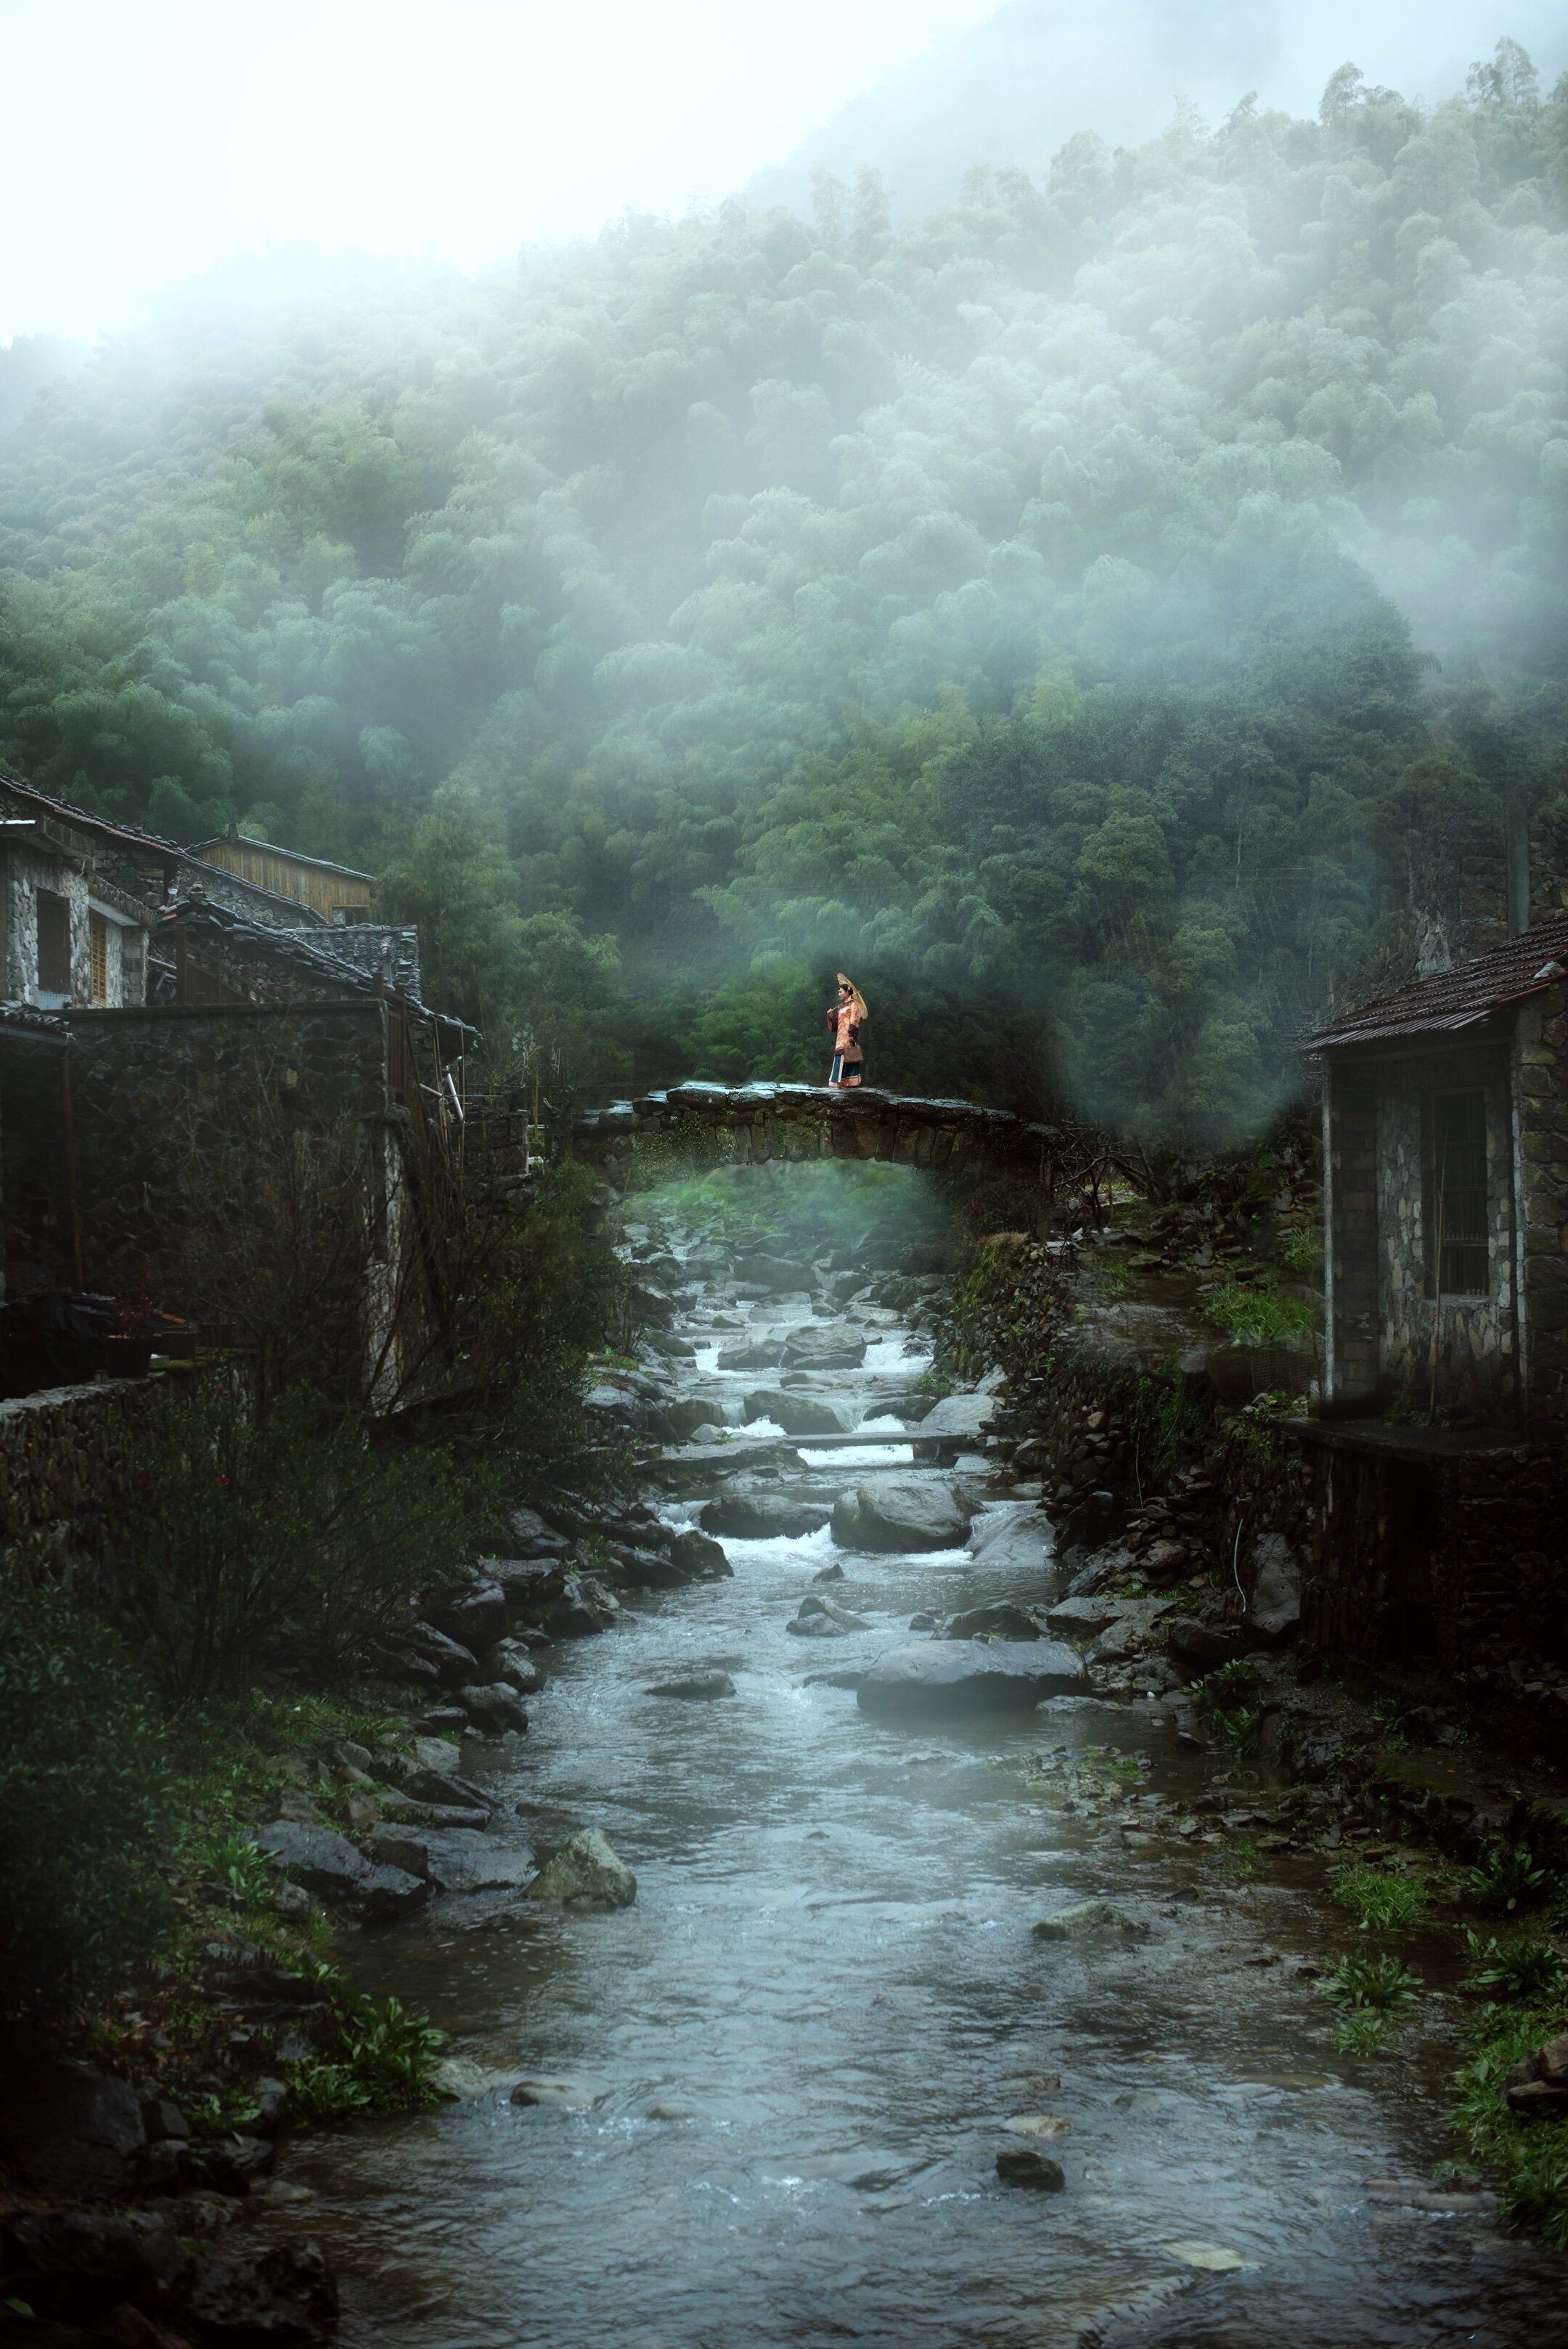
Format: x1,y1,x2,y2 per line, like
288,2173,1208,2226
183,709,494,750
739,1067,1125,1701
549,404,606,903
0,0,995,343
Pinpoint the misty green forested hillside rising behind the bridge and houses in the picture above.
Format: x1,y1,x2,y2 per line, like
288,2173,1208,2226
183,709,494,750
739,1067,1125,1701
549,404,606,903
0,44,1568,1135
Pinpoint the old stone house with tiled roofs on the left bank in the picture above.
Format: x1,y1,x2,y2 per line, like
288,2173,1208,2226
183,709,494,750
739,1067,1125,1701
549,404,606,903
0,783,473,1402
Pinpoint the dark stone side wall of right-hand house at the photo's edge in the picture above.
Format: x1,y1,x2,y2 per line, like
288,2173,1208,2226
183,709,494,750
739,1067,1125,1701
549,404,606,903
1514,984,1568,1428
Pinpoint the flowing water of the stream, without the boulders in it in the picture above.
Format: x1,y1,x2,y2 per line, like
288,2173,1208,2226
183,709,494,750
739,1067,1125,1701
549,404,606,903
282,1240,1568,2349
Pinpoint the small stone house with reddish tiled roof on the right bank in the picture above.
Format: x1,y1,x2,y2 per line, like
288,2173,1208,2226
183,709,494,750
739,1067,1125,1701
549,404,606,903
1295,914,1568,1670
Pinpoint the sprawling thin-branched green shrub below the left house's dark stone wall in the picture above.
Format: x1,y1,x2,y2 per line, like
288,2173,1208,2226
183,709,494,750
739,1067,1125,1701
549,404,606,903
127,1388,477,1705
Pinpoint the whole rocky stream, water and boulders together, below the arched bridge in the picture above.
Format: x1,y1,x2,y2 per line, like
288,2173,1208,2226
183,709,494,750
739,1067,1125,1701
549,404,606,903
138,1231,1568,2349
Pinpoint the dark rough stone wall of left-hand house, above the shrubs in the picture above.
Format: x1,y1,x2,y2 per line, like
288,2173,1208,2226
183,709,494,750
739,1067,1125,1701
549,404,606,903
70,1001,391,1294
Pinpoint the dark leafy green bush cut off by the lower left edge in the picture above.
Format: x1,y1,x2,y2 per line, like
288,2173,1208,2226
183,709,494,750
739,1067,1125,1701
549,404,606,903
0,1553,174,2015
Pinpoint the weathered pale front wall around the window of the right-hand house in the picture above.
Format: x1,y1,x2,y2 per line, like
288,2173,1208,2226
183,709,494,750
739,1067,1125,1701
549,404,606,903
1378,1045,1519,1419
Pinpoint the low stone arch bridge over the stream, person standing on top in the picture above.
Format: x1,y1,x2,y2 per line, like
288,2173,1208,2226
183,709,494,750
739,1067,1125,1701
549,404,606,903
571,1083,1058,1182
